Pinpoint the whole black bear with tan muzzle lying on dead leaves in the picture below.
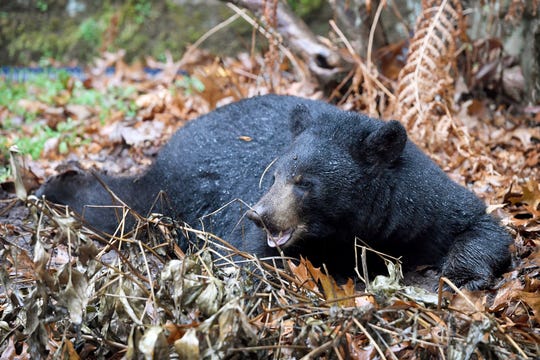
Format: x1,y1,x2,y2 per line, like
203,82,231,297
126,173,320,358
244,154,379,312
38,95,512,289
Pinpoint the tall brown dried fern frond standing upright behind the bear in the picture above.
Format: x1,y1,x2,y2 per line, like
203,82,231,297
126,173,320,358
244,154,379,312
396,0,464,147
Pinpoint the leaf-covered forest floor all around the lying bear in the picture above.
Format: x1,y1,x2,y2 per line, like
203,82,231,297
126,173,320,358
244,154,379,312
0,52,540,359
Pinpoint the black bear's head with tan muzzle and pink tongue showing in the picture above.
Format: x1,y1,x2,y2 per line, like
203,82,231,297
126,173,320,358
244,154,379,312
247,105,407,248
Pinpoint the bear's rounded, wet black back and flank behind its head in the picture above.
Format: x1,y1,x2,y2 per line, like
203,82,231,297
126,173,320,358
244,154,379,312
143,95,335,236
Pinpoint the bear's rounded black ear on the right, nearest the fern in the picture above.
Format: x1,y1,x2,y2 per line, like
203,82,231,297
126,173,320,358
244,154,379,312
362,120,407,163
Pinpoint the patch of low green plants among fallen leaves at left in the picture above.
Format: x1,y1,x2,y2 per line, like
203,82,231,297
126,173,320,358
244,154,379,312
0,72,137,159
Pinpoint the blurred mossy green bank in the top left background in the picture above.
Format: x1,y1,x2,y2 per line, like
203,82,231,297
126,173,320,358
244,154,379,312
0,0,268,65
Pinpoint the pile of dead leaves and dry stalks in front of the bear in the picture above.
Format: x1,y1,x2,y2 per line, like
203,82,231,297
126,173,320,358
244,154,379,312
0,188,540,359
